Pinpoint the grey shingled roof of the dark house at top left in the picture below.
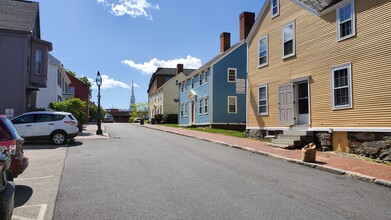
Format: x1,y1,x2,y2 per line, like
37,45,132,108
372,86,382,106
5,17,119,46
0,0,39,33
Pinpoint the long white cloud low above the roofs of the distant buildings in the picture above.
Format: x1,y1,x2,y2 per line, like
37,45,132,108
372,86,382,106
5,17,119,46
121,55,202,75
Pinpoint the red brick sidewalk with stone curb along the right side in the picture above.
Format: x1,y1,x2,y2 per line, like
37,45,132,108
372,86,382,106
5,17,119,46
140,124,391,187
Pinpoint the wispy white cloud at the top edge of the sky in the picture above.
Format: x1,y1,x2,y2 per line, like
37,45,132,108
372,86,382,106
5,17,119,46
96,0,160,20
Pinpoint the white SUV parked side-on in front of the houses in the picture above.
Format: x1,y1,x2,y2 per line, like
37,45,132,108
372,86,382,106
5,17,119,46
12,111,79,145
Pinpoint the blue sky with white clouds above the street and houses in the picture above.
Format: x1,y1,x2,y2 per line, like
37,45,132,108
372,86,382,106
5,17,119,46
35,0,264,109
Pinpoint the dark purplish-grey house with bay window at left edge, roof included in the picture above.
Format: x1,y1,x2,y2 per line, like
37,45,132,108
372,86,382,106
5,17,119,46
0,0,52,116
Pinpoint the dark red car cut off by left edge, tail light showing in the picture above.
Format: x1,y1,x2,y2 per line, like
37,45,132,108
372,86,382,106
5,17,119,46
0,115,29,181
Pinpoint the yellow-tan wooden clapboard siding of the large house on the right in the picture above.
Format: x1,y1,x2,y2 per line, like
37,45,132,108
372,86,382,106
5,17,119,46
247,0,391,128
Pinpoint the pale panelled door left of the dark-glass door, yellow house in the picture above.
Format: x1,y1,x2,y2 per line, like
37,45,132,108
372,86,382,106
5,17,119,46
278,84,295,126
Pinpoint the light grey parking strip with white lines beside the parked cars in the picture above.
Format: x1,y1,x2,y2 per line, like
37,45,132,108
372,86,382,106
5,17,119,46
12,143,67,220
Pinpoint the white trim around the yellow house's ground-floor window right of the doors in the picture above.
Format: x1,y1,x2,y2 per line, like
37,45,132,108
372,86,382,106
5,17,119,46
330,63,353,110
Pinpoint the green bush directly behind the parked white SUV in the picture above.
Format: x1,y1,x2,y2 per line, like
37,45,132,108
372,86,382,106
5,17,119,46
49,98,87,130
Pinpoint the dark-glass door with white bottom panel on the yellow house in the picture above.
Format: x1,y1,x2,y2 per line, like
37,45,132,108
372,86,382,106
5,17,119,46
295,81,309,125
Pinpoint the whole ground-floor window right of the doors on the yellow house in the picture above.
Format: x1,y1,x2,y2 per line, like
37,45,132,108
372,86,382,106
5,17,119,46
331,64,353,109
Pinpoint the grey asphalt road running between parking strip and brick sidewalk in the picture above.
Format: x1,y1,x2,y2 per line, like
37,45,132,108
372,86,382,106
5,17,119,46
54,123,391,219
